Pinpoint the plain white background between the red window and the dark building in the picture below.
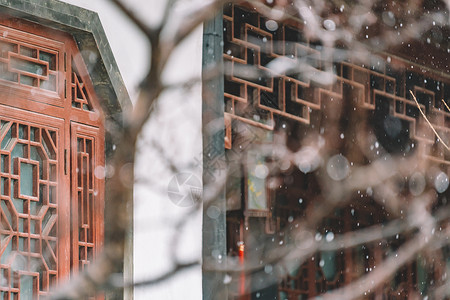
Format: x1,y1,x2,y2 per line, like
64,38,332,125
59,0,203,300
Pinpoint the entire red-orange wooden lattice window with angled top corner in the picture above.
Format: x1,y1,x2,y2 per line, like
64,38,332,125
0,17,104,299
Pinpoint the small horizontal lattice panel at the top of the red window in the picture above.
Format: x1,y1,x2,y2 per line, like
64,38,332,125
0,25,65,106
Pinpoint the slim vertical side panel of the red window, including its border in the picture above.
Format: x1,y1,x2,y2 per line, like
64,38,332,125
71,122,104,272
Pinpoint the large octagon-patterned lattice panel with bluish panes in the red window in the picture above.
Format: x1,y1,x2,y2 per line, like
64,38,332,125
0,117,61,299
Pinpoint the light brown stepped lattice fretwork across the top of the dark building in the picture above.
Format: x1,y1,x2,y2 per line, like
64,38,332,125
223,4,450,165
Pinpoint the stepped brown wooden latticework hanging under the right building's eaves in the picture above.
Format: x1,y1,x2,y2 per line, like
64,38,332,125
223,4,450,164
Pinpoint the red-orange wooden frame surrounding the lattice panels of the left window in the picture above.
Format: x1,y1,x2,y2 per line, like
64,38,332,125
0,14,105,299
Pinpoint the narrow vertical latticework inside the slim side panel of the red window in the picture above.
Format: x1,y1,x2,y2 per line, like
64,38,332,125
72,136,97,270
